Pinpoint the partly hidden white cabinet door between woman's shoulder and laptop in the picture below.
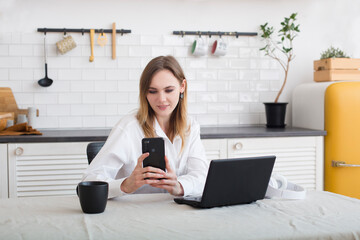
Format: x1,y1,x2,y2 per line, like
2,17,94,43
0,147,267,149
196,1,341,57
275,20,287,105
201,139,227,161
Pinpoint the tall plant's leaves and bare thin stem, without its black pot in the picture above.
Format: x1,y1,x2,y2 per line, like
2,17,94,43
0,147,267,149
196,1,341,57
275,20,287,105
260,13,300,102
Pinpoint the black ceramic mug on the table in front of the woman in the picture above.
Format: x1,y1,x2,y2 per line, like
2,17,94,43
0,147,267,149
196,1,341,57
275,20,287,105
76,181,109,213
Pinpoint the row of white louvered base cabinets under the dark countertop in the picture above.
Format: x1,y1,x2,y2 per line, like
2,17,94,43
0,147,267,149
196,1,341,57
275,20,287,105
0,136,323,198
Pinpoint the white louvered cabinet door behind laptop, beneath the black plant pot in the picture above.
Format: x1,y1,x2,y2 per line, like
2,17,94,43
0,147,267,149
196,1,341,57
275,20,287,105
228,137,323,190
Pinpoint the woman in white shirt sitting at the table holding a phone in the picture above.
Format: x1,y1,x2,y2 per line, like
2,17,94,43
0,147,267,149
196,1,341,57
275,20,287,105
83,56,208,198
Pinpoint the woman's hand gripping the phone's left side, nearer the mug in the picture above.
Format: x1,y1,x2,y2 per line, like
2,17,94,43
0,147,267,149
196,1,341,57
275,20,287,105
120,153,165,193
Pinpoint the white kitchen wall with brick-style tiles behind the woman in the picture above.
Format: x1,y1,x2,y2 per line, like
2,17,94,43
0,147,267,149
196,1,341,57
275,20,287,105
0,0,360,128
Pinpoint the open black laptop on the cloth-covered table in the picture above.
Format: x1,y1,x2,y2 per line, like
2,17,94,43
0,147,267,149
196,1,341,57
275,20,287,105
174,156,276,208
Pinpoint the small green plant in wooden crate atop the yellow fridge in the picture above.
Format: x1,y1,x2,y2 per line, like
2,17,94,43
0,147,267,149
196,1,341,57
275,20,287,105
314,46,360,82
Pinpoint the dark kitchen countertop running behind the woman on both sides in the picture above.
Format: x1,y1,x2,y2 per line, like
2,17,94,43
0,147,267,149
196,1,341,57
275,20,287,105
0,126,326,143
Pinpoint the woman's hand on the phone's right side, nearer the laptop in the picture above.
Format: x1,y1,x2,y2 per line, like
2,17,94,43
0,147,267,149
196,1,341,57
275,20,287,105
150,156,184,196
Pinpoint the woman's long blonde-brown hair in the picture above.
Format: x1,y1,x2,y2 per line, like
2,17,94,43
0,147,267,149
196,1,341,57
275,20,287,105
136,56,188,150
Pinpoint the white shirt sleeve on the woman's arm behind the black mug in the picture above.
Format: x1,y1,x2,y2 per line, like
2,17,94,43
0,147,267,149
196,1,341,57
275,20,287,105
82,127,131,198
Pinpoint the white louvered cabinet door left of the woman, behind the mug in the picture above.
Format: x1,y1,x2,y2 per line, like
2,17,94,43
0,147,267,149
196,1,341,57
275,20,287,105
8,142,88,197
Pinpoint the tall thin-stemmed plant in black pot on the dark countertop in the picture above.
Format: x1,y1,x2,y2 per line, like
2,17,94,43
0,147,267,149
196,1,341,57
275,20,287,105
260,13,300,128
